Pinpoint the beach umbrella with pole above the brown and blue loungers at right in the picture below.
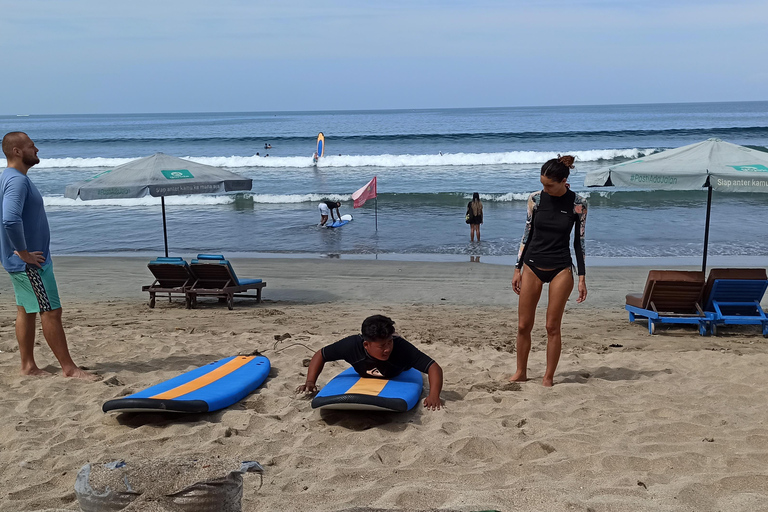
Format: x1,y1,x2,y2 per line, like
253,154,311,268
584,139,768,271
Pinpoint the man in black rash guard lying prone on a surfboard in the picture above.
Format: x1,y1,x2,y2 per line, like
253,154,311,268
296,315,443,411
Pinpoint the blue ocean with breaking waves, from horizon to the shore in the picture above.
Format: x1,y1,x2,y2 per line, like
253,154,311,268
0,101,768,265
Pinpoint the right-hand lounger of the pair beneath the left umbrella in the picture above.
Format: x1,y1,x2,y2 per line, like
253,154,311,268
186,254,267,309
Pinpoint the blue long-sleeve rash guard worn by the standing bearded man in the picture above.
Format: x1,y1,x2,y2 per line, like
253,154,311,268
0,167,51,272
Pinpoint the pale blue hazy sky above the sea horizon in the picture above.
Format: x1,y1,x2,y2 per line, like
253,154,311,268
0,0,768,115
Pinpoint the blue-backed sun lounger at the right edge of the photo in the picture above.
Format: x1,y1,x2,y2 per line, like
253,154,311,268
704,268,768,337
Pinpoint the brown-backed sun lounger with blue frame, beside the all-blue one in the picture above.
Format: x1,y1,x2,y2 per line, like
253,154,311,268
624,270,714,336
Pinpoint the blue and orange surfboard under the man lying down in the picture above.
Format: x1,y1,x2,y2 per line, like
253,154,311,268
312,368,424,412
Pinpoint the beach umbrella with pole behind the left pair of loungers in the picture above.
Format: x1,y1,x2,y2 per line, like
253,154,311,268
64,153,252,256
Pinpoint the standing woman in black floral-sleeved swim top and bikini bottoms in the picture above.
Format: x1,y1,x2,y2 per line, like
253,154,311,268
509,155,587,386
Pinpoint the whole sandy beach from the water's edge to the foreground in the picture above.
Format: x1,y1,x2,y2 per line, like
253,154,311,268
0,257,768,512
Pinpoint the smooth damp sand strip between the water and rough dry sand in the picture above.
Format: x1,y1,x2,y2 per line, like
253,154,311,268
0,255,768,312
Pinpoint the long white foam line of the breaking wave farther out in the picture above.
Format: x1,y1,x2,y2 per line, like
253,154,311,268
37,148,657,168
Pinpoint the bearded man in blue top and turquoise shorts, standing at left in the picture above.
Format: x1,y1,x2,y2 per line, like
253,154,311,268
0,132,99,381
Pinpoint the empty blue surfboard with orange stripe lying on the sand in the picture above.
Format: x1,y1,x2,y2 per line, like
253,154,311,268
102,356,270,413
